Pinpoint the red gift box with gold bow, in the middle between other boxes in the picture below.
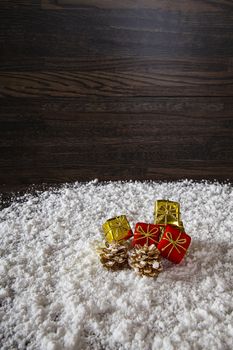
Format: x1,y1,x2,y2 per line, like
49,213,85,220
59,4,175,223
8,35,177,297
132,222,161,246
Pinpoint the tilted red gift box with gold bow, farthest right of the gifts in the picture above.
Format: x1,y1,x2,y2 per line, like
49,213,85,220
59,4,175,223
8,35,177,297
157,225,191,264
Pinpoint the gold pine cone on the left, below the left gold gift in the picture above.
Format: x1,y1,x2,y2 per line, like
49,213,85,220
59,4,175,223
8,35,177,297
96,241,129,270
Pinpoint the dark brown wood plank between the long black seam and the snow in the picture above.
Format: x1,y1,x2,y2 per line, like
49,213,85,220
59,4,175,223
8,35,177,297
0,98,233,186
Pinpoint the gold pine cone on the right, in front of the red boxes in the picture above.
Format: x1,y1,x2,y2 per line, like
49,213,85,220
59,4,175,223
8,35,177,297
128,244,162,277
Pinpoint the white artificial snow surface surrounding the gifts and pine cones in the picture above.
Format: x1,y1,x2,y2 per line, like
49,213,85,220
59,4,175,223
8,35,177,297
0,181,233,350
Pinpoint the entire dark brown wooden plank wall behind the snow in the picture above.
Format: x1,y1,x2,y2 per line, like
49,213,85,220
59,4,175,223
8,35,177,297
0,0,233,191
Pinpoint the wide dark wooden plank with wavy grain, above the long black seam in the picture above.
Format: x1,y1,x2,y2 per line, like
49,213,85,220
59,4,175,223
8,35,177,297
0,1,233,97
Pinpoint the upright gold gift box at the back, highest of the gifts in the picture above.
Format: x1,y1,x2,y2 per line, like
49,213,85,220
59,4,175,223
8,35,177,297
154,200,182,226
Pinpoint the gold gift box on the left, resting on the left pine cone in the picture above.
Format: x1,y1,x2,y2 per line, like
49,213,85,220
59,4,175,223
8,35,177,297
102,215,133,243
